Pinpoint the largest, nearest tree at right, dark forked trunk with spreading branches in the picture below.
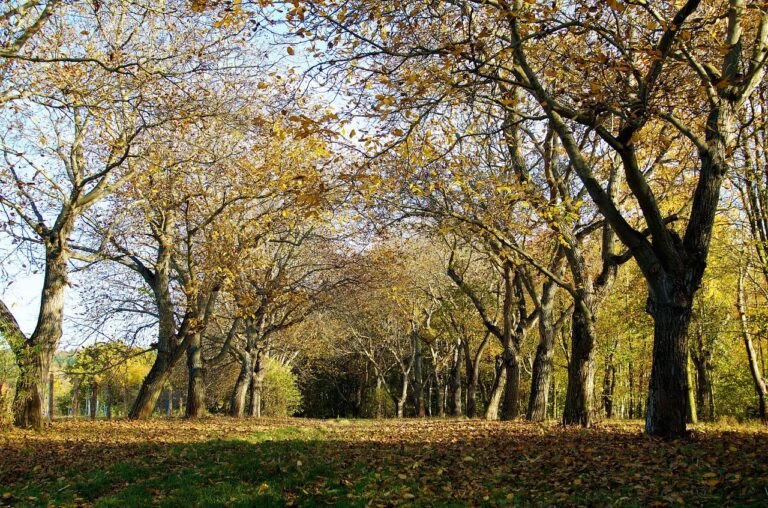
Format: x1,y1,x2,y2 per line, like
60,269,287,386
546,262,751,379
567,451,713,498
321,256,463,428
286,0,768,438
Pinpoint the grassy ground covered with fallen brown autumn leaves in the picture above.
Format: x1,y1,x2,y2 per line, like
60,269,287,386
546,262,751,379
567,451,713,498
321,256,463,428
0,417,768,507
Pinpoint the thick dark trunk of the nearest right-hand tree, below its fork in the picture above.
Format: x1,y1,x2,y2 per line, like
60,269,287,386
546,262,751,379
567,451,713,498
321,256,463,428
645,300,691,439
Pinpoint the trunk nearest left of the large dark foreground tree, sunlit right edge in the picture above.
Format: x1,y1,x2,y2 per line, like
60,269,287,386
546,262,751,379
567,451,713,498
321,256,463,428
563,303,595,427
